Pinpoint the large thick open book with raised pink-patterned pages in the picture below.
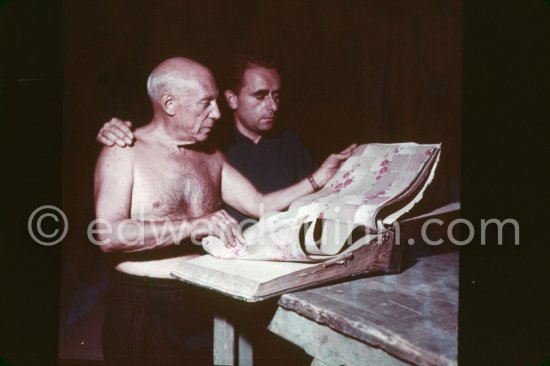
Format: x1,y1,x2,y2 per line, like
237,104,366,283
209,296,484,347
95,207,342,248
172,142,441,302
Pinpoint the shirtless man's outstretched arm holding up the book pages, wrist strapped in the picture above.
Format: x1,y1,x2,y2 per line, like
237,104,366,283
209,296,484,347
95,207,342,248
222,144,357,217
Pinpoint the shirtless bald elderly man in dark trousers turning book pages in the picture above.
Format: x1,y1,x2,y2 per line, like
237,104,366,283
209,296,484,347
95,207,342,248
95,57,355,364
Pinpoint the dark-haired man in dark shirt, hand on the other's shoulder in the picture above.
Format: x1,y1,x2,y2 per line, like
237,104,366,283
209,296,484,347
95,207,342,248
97,55,315,222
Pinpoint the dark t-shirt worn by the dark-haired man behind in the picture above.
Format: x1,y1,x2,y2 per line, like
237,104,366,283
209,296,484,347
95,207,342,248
225,129,315,222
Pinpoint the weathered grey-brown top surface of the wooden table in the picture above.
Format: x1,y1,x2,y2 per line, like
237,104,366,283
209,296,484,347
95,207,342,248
275,251,458,365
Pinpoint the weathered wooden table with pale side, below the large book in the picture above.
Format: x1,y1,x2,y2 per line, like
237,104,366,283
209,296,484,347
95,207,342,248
269,248,458,365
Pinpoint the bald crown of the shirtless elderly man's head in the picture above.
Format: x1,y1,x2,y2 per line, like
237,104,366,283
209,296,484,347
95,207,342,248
147,57,213,105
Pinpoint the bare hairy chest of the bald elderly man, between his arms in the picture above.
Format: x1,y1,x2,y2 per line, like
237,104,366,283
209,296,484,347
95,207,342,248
131,147,221,219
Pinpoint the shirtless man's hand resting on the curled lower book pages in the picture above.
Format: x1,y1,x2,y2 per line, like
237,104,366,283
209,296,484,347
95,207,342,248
191,210,246,248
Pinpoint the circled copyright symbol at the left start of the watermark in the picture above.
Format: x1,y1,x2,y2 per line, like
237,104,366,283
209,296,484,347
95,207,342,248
27,205,69,247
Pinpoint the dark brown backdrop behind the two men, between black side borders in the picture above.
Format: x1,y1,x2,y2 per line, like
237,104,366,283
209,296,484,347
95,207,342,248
60,0,462,358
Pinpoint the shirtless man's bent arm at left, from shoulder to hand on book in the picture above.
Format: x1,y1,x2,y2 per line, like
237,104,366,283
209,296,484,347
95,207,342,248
94,147,244,252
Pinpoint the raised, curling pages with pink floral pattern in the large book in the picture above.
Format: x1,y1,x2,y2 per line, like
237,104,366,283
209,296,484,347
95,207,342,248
202,142,441,262
